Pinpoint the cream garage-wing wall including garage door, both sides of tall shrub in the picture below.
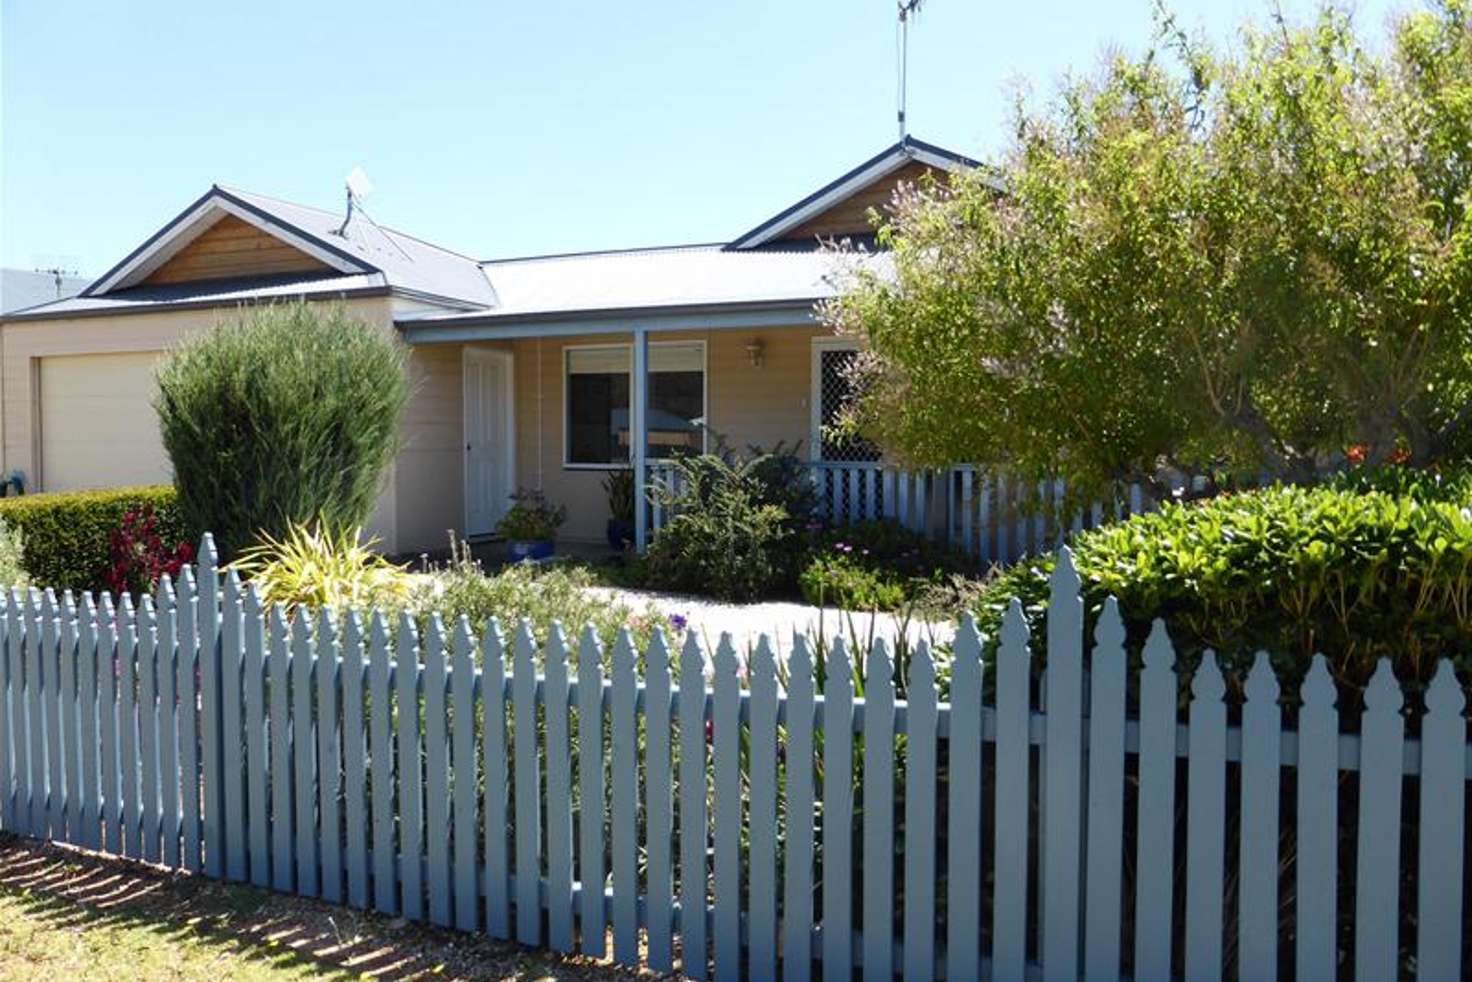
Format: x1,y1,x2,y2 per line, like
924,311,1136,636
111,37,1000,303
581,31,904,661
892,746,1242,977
0,297,464,552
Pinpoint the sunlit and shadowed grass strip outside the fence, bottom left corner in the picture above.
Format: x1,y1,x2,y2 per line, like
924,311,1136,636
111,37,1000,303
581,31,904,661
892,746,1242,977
0,836,651,982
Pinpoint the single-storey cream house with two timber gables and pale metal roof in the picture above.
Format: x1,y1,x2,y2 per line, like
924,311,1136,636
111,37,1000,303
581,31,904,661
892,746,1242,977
0,140,974,552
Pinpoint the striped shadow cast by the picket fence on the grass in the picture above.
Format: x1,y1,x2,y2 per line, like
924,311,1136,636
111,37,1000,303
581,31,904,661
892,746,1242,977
0,835,651,981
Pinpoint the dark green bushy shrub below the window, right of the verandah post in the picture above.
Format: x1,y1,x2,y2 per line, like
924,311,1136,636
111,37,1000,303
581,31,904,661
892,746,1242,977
643,453,810,601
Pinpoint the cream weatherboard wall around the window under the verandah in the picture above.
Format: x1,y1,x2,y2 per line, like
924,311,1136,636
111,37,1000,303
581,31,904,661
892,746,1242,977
512,325,826,542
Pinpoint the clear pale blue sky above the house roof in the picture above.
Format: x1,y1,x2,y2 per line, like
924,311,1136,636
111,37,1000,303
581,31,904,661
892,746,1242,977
0,0,1415,275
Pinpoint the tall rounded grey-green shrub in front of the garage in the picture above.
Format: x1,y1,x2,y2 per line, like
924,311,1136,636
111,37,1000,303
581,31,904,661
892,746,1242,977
155,303,409,558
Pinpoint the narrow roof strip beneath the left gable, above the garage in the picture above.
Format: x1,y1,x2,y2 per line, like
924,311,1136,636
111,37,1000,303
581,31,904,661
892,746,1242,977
6,272,389,321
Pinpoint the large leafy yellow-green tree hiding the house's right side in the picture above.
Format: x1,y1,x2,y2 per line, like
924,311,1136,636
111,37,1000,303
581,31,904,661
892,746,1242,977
824,0,1472,515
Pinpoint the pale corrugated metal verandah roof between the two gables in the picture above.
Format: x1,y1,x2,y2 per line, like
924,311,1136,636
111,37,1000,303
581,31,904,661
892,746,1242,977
400,246,889,322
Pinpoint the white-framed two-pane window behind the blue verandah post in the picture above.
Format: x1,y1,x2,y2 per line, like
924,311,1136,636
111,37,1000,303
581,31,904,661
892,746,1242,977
565,342,705,467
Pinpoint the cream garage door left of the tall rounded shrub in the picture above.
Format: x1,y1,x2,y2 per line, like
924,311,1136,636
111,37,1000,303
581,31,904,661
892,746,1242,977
41,352,169,490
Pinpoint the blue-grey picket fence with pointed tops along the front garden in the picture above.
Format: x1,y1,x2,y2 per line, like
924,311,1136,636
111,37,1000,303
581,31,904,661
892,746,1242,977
0,537,1472,982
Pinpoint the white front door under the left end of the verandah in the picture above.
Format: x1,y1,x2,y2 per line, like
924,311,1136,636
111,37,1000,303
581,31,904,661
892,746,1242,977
465,347,515,537
